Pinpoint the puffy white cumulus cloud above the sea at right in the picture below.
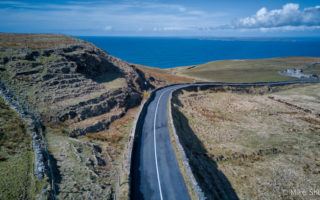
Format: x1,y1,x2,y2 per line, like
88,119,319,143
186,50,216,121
232,3,320,31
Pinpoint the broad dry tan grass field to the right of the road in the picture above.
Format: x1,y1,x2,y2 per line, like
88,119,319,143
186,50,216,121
175,85,320,199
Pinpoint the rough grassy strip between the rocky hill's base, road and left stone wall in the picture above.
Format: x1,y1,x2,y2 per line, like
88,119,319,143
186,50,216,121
47,108,139,199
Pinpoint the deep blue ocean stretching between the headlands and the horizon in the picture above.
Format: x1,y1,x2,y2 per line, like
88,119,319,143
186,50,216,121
79,36,320,68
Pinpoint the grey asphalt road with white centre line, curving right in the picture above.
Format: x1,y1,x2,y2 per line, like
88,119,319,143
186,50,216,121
130,81,316,200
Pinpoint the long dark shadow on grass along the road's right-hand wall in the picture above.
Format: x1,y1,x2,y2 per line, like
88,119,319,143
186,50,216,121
172,95,239,199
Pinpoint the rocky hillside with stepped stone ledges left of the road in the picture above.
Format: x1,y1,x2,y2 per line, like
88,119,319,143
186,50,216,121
0,34,152,136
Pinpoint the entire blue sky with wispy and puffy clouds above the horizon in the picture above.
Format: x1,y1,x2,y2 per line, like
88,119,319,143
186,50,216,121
0,0,320,37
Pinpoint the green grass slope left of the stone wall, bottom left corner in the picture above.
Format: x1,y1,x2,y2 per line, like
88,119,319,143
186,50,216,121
0,98,45,200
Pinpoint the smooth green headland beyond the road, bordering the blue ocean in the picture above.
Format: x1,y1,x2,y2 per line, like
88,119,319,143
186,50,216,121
171,57,320,82
